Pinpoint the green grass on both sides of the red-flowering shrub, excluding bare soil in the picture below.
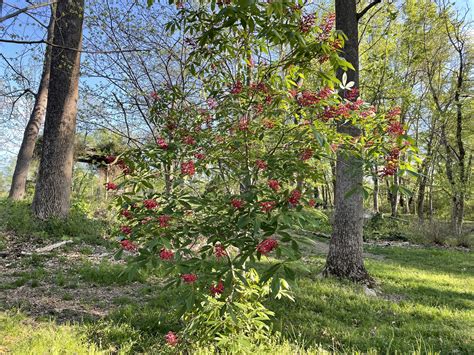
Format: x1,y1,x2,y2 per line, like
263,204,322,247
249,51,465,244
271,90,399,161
0,241,474,354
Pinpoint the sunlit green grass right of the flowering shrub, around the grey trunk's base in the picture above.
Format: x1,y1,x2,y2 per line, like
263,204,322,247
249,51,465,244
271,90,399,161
271,248,474,354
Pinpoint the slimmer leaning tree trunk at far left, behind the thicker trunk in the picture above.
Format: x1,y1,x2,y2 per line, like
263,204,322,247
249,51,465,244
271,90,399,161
8,6,55,201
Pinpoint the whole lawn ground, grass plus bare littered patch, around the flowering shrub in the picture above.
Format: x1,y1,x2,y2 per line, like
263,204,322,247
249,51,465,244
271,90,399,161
0,202,474,354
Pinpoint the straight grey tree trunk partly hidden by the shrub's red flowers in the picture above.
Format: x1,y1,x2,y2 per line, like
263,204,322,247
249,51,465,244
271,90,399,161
323,0,372,282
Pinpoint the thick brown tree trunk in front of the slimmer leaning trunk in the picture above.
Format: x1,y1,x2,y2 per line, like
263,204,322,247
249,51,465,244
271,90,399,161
32,0,84,219
